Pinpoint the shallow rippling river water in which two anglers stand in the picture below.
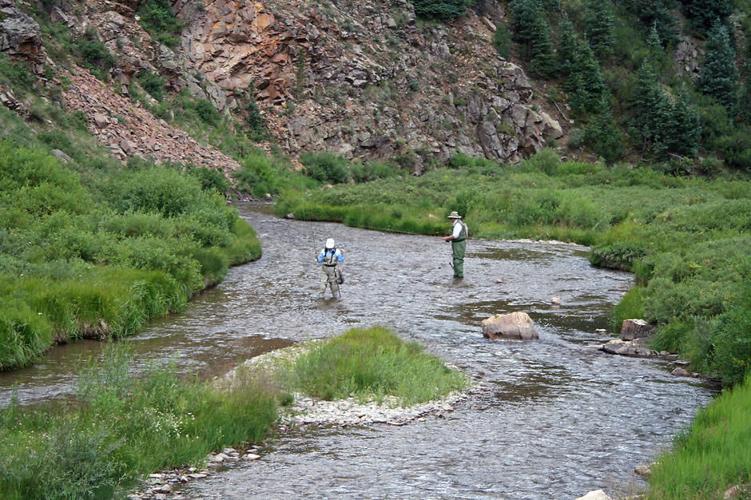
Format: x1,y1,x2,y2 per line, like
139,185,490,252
0,206,711,498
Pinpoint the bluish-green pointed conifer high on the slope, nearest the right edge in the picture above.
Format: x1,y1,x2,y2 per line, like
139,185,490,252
698,22,738,110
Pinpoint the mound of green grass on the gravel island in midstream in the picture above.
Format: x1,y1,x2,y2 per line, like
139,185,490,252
288,327,468,406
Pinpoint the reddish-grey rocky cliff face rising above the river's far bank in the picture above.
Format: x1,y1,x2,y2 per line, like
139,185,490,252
3,0,563,170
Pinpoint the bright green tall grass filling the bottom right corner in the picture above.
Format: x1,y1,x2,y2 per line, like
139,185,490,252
647,376,751,500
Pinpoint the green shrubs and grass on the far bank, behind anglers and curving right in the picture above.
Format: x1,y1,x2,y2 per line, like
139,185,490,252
276,151,751,383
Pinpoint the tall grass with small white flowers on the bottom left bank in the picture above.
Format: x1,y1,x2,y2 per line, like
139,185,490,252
0,347,280,500
